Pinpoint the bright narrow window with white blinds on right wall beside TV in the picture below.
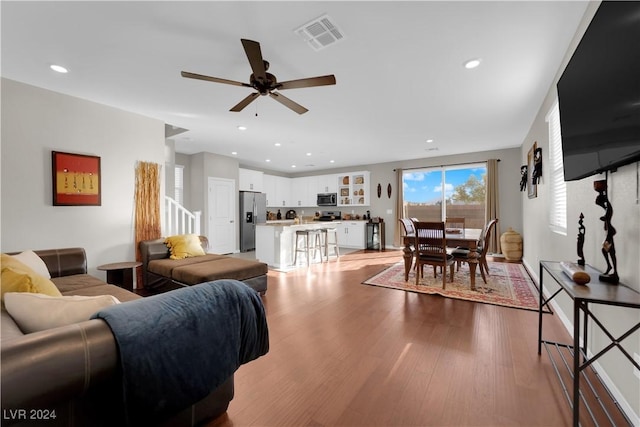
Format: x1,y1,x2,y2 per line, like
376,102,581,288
546,100,567,236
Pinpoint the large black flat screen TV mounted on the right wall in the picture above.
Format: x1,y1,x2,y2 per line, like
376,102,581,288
557,1,640,181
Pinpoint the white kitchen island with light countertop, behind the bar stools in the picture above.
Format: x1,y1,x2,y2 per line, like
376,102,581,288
256,221,340,271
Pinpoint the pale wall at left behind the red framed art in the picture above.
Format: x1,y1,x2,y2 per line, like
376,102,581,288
0,79,165,279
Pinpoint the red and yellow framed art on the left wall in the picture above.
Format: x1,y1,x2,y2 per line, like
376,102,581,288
51,151,102,206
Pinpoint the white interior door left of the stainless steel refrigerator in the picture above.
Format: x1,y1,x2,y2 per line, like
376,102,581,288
207,177,237,254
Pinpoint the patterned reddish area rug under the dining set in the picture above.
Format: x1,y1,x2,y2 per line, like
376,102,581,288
362,262,539,311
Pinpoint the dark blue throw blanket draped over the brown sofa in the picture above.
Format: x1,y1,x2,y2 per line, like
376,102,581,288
93,280,269,425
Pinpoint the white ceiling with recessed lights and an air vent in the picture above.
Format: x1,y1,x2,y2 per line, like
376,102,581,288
0,1,587,173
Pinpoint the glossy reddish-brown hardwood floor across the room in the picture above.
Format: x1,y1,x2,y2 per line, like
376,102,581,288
202,251,628,427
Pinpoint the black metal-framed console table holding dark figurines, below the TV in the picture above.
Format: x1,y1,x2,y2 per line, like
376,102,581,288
538,261,640,427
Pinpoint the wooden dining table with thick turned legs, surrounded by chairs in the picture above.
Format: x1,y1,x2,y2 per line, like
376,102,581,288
402,228,482,291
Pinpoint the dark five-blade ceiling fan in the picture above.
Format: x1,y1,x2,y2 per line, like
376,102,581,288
180,39,336,114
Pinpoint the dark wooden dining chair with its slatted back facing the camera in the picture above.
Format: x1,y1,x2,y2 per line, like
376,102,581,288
413,221,454,289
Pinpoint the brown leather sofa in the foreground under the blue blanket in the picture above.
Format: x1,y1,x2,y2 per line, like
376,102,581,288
0,248,234,426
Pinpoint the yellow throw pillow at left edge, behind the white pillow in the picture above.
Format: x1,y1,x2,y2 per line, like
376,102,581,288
0,254,62,300
